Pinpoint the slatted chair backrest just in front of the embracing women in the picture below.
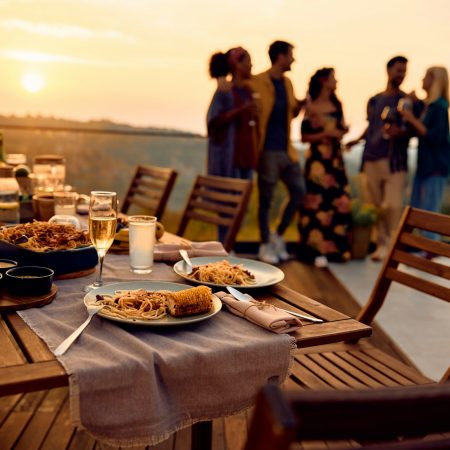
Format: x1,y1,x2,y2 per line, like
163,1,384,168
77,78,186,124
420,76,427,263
177,175,252,251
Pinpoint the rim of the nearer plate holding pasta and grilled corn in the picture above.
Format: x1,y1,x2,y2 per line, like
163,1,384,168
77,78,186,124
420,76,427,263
83,280,222,327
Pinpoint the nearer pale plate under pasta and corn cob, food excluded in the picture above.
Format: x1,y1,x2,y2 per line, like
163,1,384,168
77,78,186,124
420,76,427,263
84,281,222,327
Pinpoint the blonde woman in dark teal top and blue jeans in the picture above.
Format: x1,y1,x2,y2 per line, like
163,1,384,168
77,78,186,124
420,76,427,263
400,67,450,243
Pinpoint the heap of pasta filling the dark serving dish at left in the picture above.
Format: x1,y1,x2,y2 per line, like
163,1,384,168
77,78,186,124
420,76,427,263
0,221,91,252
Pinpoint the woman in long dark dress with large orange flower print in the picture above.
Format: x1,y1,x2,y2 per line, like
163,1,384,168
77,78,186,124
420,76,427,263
299,68,351,267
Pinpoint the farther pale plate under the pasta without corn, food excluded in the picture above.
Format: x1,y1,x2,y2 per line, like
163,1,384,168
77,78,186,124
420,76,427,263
173,256,284,289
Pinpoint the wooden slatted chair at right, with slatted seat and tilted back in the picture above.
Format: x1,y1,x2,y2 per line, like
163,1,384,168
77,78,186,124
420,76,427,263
291,207,450,389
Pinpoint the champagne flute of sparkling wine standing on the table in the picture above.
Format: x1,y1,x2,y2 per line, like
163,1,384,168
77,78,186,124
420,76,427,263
84,191,117,292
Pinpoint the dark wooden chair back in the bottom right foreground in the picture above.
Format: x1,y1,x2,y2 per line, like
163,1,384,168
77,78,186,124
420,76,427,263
245,383,450,450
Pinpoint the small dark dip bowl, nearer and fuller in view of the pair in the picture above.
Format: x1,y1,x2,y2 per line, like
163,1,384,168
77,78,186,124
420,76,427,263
5,266,55,296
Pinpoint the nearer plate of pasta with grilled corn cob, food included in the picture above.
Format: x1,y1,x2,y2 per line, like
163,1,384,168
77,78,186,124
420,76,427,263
84,281,222,326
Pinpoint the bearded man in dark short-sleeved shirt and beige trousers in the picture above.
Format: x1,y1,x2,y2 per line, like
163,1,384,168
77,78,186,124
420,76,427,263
347,56,410,261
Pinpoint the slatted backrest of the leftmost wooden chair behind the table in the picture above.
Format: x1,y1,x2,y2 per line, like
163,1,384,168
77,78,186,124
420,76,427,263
121,165,178,220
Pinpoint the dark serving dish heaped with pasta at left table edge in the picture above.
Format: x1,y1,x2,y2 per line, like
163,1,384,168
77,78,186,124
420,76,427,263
0,221,98,275
